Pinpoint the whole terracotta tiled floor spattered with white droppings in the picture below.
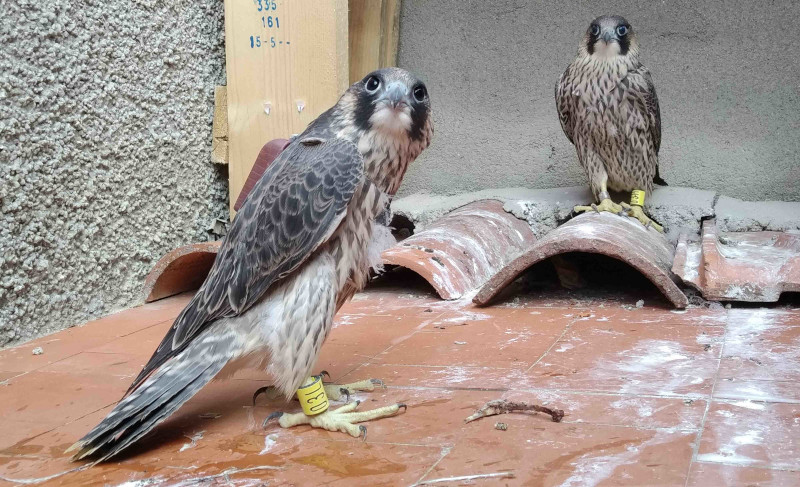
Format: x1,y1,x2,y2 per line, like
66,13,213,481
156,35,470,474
0,280,800,486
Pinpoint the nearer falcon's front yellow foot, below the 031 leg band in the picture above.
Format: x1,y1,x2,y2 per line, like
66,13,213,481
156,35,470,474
264,401,407,441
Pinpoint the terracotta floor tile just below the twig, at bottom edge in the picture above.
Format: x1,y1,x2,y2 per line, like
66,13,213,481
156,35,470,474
418,422,695,486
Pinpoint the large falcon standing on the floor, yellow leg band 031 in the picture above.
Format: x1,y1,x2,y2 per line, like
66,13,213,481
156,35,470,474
68,68,433,461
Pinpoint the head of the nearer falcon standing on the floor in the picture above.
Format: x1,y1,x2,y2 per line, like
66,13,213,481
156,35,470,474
346,68,433,141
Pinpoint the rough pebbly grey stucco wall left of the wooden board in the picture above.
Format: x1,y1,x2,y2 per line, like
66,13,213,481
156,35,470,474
0,0,227,346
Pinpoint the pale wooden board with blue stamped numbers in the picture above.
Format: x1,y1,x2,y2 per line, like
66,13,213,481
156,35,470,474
225,0,349,217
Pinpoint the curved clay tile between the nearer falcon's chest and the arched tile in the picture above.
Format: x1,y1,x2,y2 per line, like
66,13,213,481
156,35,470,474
381,200,536,299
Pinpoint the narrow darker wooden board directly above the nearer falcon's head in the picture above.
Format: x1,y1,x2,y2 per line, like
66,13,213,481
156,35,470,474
349,0,400,83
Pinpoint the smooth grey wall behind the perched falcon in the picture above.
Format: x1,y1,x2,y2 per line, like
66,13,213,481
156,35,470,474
398,0,800,201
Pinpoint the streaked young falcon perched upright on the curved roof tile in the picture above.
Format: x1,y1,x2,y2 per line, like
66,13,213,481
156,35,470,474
556,15,666,231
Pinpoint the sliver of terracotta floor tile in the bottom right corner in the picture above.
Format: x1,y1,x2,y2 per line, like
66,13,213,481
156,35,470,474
686,462,800,487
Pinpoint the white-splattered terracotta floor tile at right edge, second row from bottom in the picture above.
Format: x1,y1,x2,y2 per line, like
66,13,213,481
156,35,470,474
697,401,800,470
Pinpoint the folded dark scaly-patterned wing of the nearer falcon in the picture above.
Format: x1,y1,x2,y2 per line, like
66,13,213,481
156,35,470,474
128,138,364,392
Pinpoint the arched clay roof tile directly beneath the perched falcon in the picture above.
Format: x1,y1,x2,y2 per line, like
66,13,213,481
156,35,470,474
473,212,688,308
